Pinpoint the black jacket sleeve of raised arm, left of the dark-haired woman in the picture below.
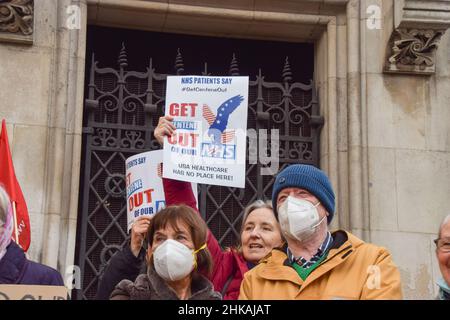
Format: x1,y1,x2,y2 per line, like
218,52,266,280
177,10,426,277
95,241,147,300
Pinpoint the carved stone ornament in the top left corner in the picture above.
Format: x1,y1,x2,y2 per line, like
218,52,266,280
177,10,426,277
0,0,34,44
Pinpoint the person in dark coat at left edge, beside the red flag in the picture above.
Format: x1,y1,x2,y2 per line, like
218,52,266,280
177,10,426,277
0,186,64,286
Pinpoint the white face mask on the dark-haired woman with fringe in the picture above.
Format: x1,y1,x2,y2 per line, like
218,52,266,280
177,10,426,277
153,239,206,281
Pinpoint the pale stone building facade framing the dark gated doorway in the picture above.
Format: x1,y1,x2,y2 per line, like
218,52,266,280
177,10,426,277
0,0,450,299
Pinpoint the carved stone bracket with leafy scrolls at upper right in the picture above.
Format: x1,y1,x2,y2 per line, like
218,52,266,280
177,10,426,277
384,0,450,75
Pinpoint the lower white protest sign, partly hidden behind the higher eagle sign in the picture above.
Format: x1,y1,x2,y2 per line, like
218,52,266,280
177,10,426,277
125,150,198,231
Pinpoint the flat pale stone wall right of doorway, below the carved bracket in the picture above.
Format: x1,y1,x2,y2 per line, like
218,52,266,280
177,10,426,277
358,1,450,299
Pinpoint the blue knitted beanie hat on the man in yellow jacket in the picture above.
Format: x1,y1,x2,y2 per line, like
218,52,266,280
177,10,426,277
272,164,335,224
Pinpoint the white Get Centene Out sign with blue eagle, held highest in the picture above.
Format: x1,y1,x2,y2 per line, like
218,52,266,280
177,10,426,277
163,76,249,188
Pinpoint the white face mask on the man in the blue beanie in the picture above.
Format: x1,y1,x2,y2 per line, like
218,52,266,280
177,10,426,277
278,196,326,241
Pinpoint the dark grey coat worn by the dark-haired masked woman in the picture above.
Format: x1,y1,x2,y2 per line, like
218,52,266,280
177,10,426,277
110,267,222,300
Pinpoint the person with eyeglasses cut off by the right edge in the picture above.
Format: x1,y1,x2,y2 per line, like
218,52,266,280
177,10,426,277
434,215,450,300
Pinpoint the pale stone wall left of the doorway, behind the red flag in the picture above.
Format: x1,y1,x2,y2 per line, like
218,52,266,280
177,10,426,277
0,2,57,261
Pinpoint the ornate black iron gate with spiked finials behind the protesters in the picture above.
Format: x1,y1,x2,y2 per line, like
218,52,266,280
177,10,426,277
76,46,323,299
